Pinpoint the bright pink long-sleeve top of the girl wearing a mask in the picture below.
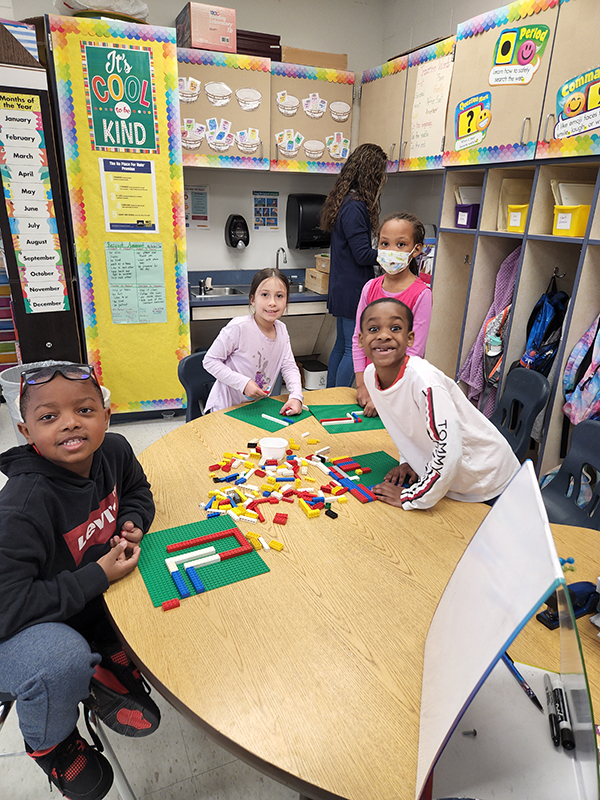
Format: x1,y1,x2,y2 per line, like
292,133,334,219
352,275,433,372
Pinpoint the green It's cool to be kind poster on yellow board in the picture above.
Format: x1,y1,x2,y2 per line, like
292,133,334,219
81,42,159,153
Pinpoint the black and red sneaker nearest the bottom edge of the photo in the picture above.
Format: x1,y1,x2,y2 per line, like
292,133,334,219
25,728,113,800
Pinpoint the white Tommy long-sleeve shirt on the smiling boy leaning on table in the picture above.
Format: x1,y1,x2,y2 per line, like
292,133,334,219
365,356,520,510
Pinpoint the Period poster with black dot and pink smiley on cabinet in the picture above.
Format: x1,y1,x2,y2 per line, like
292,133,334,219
489,25,550,86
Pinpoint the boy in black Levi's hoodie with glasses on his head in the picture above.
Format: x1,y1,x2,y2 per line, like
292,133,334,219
0,365,160,800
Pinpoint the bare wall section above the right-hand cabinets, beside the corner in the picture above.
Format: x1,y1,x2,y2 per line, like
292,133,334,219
382,0,504,61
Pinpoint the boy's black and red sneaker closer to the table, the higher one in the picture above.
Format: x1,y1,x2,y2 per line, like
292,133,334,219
84,653,160,738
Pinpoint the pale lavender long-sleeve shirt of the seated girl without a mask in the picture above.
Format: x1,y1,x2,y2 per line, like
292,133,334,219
203,314,303,411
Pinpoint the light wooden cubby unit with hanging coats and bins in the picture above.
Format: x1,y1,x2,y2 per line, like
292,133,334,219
425,159,600,474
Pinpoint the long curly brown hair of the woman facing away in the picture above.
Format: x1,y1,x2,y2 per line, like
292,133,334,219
320,144,387,232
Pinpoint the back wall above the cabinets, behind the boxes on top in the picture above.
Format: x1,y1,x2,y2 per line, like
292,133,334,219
18,0,384,72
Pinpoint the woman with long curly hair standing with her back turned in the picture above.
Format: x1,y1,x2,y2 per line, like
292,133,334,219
321,144,387,388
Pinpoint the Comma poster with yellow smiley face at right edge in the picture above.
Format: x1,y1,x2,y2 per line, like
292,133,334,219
554,67,600,139
